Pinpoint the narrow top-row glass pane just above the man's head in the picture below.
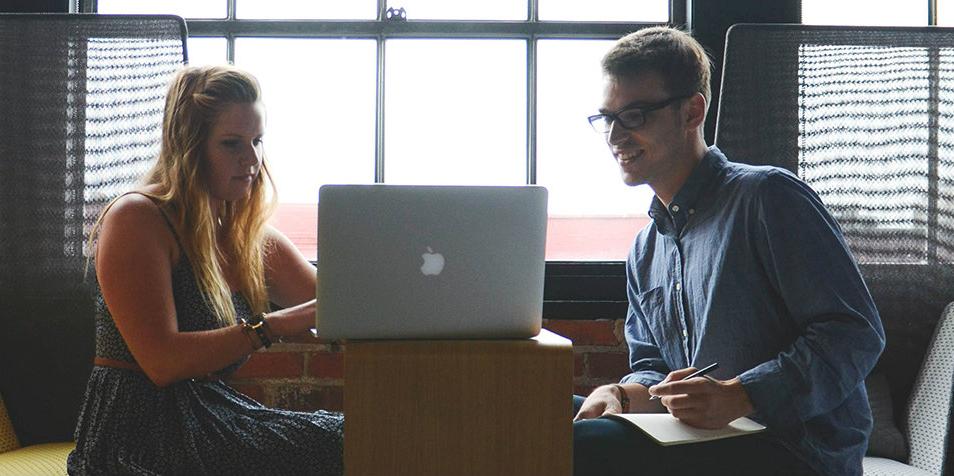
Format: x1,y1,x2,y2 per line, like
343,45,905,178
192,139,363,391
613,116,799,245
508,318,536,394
539,0,669,23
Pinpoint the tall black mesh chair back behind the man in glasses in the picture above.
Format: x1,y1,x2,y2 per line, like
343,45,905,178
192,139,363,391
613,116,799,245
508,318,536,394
715,24,954,474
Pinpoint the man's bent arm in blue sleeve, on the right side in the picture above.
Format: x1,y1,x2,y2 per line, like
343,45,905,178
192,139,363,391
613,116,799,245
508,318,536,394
739,172,884,425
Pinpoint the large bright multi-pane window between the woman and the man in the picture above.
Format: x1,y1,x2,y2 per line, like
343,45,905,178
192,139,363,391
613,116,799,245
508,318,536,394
89,0,668,262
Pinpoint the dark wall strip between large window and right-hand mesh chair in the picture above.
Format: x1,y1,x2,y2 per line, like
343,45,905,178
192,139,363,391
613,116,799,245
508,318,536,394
688,0,802,144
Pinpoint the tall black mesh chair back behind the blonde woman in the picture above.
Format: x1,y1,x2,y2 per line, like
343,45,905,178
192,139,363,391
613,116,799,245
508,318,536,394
0,14,186,446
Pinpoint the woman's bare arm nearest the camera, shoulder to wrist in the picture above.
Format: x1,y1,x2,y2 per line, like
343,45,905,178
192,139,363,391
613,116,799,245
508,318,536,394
96,194,253,387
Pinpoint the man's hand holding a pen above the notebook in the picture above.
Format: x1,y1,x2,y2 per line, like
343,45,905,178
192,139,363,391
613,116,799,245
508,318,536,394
648,367,755,429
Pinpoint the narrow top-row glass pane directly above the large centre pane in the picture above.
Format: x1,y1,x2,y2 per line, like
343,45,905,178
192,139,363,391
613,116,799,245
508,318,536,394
389,0,528,20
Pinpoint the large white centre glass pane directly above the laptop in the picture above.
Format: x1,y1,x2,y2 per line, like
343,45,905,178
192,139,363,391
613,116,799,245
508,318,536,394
384,40,527,185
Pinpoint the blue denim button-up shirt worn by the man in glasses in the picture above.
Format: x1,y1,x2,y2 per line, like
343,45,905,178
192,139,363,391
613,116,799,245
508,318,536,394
622,147,884,476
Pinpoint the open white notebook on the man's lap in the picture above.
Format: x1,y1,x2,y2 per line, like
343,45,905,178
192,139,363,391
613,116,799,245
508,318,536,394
603,413,765,446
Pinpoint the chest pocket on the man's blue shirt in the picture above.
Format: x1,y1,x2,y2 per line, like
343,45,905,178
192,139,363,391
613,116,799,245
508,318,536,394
637,286,686,368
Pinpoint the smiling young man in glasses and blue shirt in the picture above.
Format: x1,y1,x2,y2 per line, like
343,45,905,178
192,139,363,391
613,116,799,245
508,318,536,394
574,27,884,476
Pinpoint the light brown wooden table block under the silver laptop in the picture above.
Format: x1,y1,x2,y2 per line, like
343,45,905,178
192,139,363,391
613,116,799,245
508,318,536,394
344,329,573,476
